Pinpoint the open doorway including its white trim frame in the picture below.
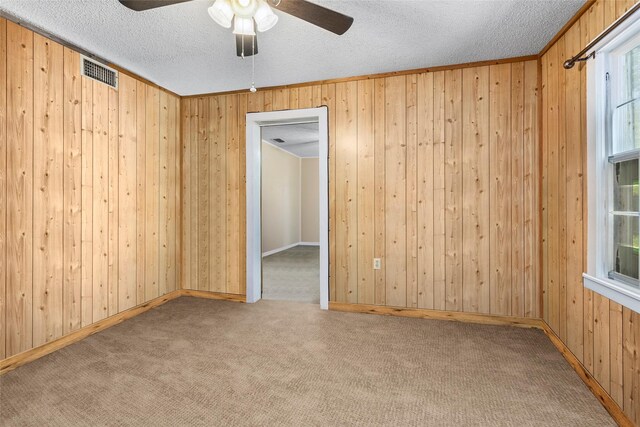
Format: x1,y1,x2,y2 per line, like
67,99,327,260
242,107,329,309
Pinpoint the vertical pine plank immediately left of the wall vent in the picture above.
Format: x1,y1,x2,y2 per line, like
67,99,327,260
61,46,82,334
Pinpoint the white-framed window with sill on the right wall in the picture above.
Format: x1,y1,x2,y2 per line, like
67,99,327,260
584,9,640,312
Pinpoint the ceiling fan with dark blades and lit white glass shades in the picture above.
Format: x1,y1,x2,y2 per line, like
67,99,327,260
119,0,353,57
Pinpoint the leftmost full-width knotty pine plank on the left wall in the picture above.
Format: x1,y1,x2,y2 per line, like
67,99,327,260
5,22,33,356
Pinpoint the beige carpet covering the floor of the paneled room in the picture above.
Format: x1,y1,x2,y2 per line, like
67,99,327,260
0,298,614,427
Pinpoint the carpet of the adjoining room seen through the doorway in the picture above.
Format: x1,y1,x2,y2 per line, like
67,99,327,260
262,245,320,304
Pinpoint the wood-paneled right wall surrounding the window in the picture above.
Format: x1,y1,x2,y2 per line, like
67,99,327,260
541,0,640,424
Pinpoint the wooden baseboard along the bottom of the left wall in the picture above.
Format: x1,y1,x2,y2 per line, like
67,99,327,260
0,290,182,375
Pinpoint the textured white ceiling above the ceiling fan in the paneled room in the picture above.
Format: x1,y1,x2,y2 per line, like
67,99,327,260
0,0,584,95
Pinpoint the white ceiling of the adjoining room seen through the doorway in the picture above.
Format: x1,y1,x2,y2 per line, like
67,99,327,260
261,122,320,157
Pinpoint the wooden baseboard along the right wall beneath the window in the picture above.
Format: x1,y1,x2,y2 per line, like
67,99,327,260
541,320,634,427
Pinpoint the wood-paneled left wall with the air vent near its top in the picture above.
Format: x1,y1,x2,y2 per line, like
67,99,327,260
0,19,180,359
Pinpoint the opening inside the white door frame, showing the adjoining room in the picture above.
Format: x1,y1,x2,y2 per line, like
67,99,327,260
261,122,320,304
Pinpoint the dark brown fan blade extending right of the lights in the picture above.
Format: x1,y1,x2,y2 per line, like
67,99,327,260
270,0,353,35
